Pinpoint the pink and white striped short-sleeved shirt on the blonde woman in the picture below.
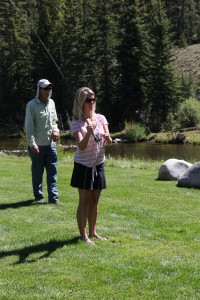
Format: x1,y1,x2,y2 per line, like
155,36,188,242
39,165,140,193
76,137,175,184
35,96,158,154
71,114,108,168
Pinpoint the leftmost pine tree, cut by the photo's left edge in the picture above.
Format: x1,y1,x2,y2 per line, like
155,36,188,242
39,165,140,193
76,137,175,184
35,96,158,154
0,0,33,119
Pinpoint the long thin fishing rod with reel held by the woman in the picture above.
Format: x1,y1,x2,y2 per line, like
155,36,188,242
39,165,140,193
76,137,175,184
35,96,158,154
9,0,101,143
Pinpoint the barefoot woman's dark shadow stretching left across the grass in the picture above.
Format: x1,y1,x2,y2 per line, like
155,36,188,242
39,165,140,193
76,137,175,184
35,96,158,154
0,237,79,264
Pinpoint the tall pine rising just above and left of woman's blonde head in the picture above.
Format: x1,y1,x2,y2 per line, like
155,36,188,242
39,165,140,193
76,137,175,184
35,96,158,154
60,0,91,114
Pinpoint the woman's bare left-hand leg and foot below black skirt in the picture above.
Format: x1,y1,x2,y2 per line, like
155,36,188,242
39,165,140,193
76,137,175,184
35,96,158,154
77,189,93,243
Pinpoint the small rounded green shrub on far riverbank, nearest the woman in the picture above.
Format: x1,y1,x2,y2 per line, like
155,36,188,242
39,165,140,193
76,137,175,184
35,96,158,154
123,122,147,142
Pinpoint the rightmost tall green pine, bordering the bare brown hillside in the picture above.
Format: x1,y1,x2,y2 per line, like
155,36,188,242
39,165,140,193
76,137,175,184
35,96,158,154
146,0,179,131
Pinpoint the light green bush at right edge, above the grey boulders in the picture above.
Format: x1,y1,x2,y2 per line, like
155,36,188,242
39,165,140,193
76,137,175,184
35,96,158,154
177,97,200,127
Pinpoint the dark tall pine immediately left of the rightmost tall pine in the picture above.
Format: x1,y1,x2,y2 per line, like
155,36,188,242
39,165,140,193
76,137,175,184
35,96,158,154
117,0,148,121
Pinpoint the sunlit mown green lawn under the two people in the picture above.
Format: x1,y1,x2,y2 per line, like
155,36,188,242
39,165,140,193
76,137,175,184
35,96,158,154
0,153,200,300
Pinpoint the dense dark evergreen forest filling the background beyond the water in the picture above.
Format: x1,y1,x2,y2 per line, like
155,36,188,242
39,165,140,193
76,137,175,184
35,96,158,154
0,0,200,131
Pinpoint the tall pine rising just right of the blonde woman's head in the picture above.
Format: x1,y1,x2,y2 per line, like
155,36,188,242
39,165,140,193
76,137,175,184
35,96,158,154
86,0,117,126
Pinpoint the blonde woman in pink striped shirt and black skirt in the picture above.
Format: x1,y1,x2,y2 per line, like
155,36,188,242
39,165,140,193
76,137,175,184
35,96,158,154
71,87,112,244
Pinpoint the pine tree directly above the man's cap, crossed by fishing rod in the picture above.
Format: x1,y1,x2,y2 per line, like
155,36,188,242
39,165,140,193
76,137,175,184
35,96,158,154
30,0,65,111
